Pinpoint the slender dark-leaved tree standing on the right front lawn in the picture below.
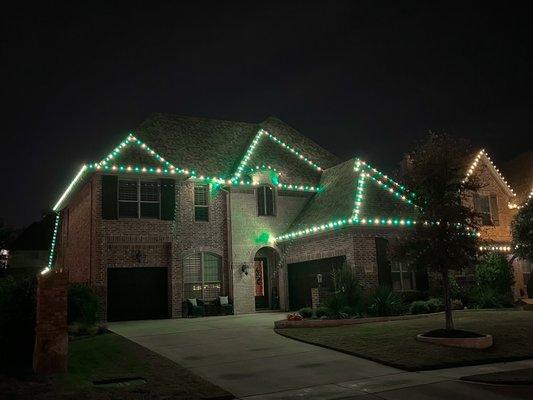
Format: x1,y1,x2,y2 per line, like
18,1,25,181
395,132,480,329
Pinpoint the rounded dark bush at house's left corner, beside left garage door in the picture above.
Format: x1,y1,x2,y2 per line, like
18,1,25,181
67,284,98,326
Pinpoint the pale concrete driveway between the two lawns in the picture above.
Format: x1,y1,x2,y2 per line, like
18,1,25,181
109,313,533,400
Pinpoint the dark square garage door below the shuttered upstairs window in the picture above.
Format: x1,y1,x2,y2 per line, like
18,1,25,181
107,267,168,321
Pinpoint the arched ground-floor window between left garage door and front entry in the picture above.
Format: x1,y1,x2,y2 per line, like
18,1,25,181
183,253,222,300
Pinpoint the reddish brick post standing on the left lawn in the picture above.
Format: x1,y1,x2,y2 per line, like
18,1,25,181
33,269,68,374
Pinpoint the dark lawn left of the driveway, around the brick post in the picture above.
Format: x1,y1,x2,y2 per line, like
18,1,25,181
0,333,233,400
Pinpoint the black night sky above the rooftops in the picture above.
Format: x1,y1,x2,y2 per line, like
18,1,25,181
0,1,533,225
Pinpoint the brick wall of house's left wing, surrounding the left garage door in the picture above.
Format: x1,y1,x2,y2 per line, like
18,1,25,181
57,174,230,320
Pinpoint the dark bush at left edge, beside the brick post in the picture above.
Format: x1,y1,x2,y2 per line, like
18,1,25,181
0,275,37,372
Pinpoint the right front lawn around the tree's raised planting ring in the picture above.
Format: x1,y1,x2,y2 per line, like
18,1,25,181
276,310,533,371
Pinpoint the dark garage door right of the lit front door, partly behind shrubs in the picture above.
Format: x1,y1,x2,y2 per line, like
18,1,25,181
288,256,345,311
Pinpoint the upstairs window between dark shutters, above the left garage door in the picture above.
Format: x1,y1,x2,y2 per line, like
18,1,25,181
118,179,160,218
